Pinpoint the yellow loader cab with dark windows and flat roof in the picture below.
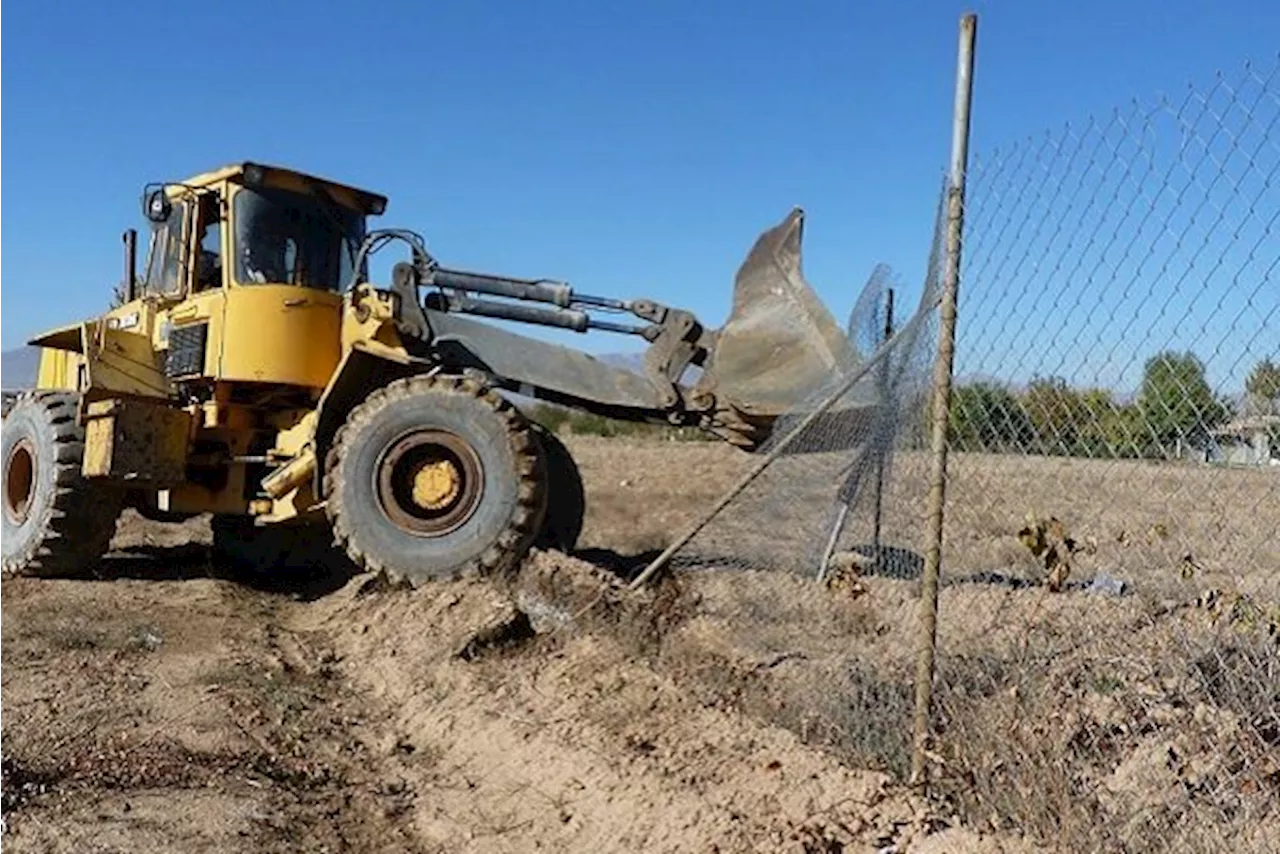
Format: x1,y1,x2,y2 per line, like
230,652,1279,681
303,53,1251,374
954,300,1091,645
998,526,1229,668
138,163,387,394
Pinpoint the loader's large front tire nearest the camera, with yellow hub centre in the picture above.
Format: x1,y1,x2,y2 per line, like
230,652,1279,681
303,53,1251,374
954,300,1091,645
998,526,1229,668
325,376,547,586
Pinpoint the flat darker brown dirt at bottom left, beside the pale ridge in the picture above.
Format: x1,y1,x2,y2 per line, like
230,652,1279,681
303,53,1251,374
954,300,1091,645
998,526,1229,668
0,566,430,854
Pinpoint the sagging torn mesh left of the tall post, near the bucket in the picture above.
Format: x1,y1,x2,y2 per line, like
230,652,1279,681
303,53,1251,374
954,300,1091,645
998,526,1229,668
672,193,941,581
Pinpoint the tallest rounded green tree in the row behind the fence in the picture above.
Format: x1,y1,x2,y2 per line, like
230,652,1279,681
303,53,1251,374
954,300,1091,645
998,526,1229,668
1137,351,1231,455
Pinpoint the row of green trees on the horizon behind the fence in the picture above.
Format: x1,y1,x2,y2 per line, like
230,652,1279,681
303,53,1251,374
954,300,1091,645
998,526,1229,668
948,351,1264,458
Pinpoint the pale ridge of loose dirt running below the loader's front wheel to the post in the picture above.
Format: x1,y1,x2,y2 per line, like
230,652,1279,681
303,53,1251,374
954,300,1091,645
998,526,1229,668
292,553,1034,851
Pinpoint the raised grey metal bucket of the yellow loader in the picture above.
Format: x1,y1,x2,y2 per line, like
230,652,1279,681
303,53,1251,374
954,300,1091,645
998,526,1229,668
701,207,852,426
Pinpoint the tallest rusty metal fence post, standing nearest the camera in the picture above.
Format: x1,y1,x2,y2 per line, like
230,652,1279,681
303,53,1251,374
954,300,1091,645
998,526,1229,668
911,13,978,785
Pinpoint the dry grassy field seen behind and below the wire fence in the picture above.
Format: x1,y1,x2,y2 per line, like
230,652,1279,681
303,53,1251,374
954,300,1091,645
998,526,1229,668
573,440,1280,854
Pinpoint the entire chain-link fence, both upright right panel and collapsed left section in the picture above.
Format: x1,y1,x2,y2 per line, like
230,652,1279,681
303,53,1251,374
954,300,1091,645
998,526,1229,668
596,20,1280,853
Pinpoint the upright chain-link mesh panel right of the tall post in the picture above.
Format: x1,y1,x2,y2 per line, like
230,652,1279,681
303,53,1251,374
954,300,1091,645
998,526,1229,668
920,56,1280,851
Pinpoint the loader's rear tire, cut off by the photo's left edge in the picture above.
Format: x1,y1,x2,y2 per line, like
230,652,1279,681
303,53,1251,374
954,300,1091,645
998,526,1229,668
0,392,124,576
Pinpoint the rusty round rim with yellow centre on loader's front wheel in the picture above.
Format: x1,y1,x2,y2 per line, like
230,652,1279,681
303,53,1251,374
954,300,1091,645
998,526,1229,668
376,430,484,536
